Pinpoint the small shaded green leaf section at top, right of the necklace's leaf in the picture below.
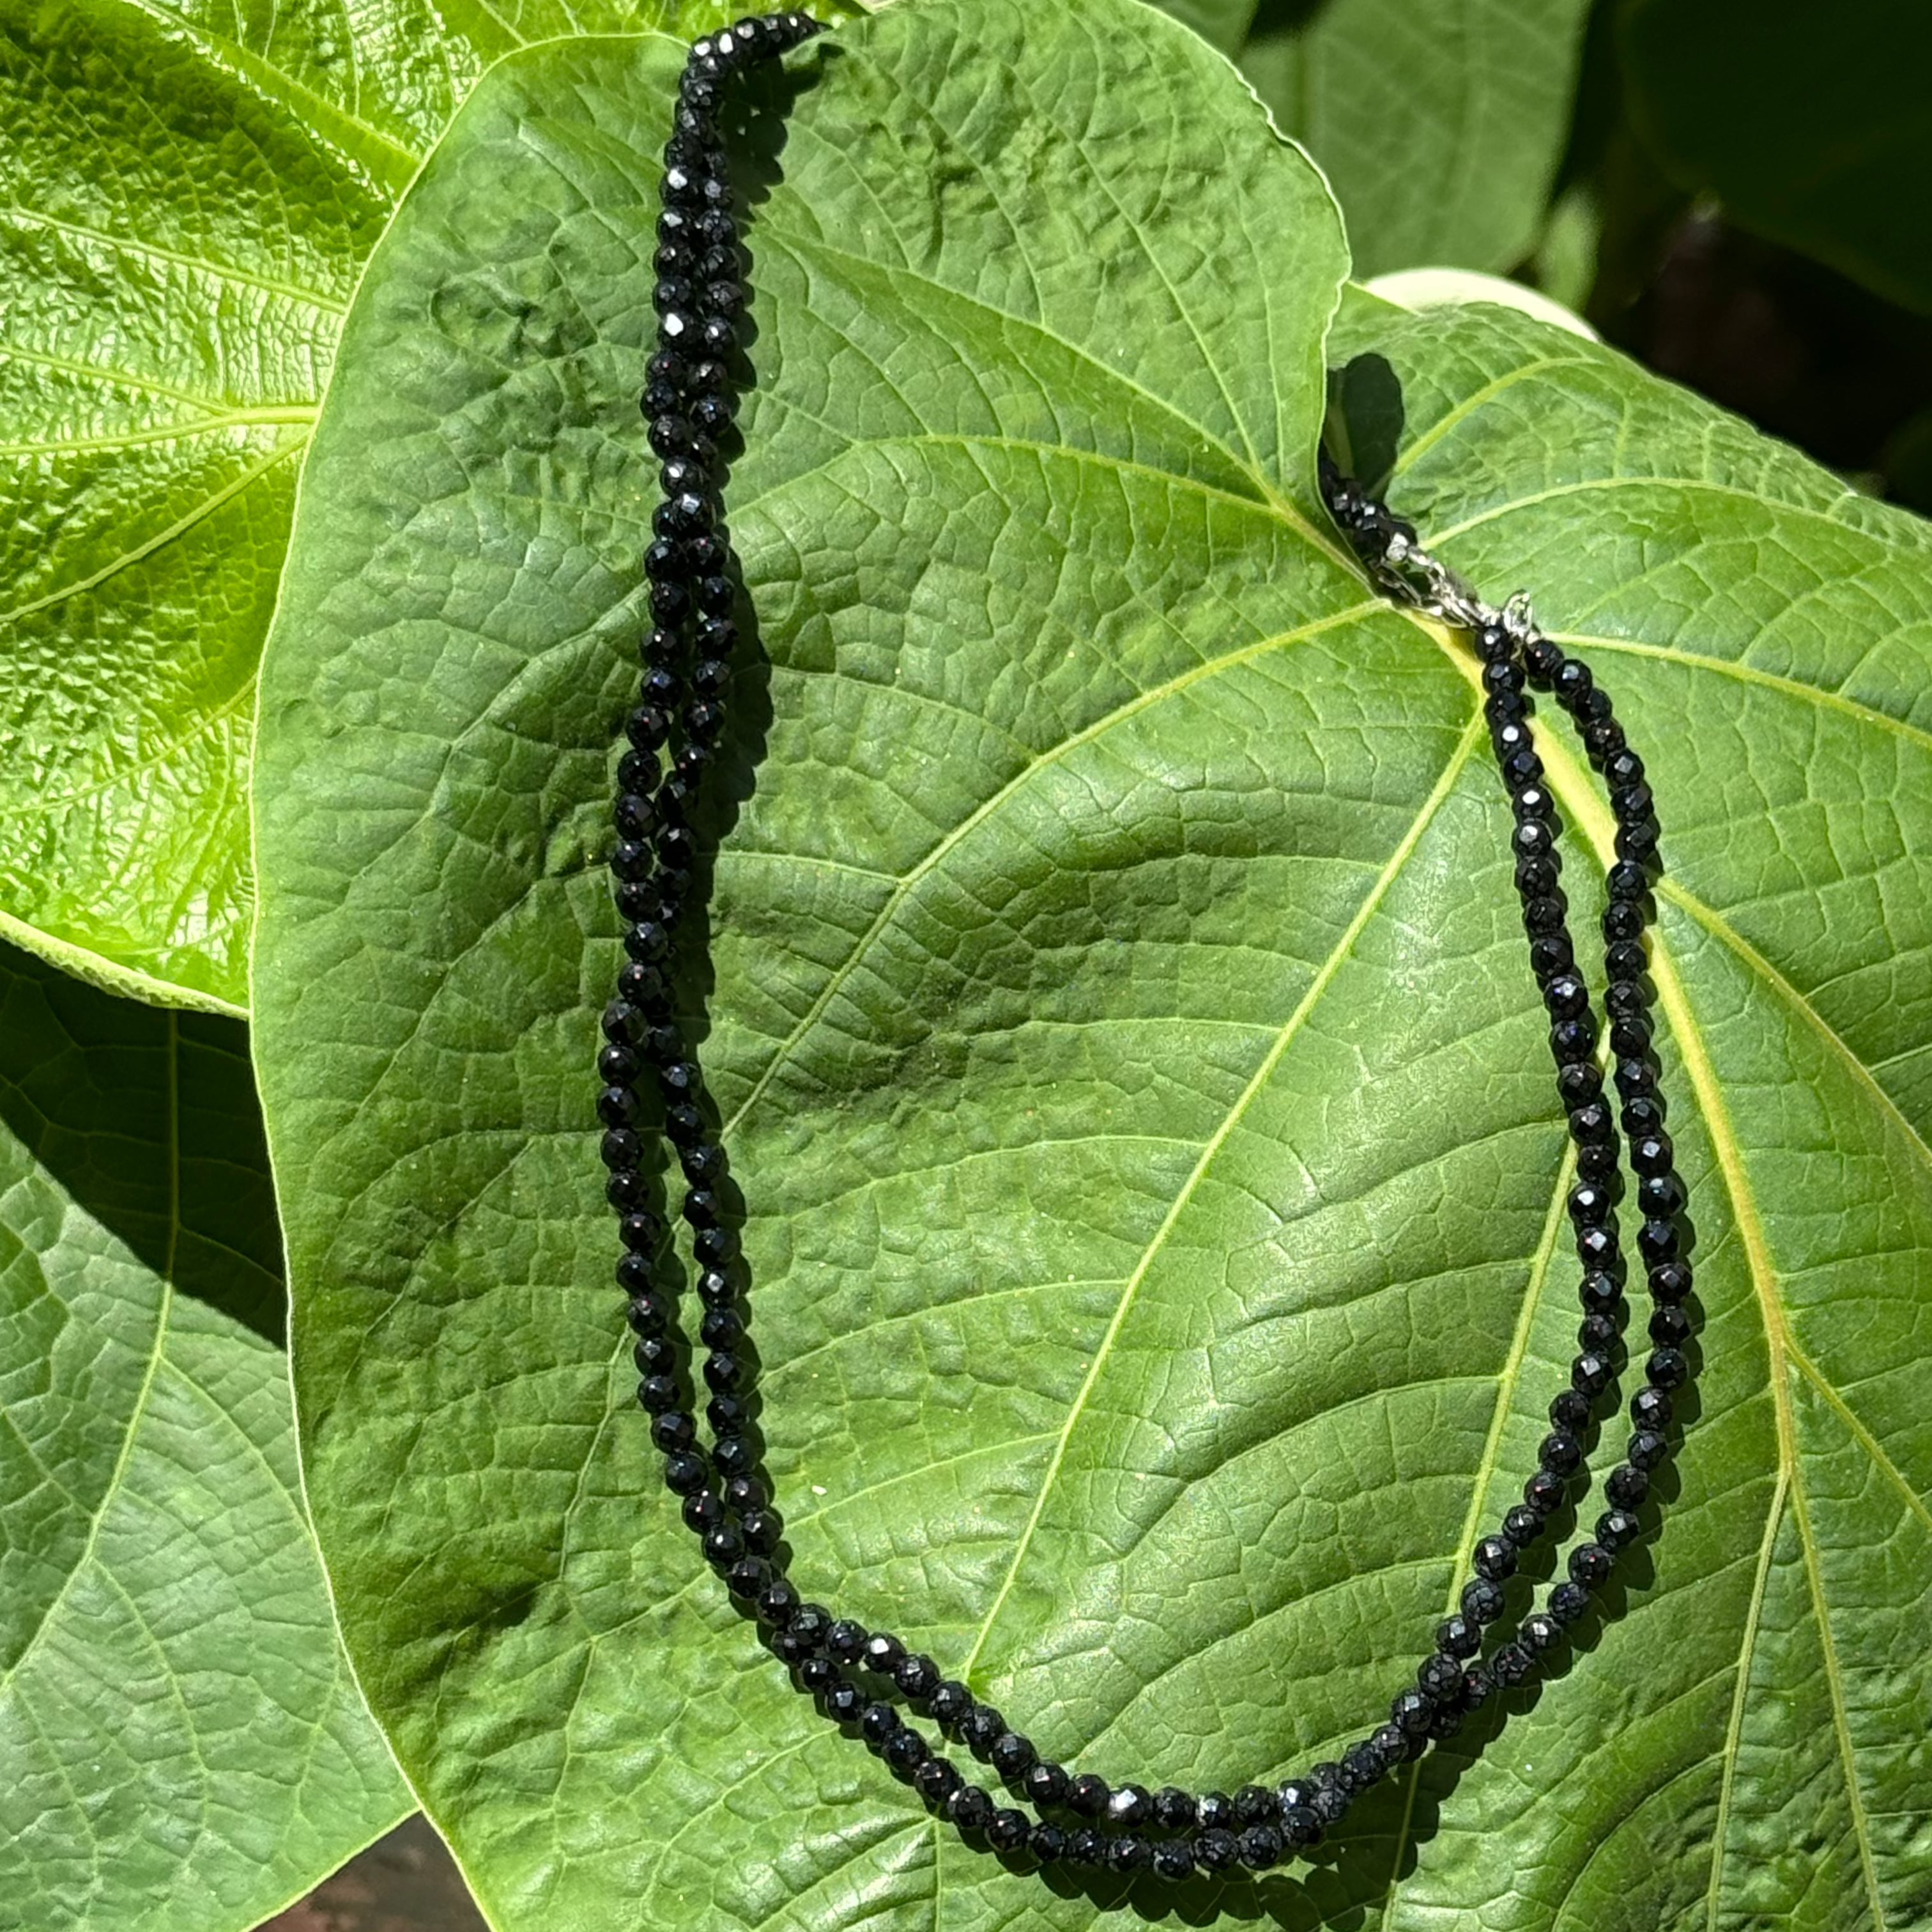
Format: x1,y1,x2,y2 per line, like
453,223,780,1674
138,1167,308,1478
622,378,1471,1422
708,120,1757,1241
1236,0,1590,278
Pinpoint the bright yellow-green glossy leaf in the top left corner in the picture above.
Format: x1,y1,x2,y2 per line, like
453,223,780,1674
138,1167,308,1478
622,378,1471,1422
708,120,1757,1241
0,0,869,1011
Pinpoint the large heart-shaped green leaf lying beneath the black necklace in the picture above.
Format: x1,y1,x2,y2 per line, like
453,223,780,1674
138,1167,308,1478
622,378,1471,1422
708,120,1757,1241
255,0,1932,1932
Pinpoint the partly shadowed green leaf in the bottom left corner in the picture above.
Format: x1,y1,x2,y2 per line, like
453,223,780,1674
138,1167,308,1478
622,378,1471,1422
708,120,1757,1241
0,947,410,1932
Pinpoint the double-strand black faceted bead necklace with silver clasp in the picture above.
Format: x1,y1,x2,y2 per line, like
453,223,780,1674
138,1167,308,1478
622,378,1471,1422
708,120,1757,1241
597,13,1690,1880
